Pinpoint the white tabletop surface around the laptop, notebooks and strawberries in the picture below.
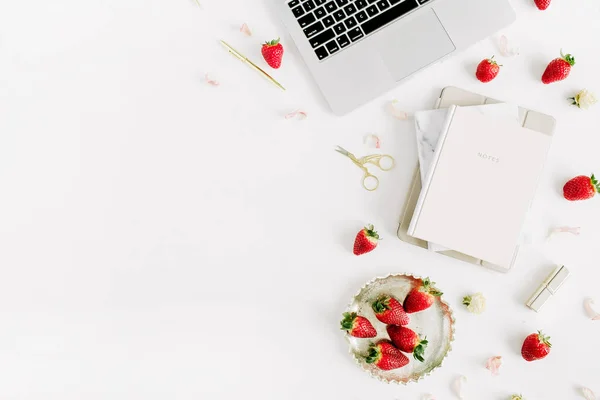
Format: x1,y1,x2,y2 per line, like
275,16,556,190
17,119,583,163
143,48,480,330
0,0,600,400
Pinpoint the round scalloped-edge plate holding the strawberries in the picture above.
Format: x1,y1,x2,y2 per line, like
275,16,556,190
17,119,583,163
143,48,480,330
346,274,455,384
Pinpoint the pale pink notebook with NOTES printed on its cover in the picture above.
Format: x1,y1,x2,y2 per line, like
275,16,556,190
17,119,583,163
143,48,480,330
408,106,551,268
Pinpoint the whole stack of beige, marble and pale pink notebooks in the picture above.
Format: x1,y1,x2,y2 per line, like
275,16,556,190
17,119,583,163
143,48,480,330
398,88,555,271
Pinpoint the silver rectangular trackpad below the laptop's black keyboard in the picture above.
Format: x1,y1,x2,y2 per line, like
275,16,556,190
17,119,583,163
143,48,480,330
378,9,456,81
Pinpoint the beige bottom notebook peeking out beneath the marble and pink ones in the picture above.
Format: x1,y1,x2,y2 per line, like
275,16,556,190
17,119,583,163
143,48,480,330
398,87,556,272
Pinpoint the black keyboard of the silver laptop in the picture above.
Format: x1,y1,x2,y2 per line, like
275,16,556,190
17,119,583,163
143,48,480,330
288,0,429,60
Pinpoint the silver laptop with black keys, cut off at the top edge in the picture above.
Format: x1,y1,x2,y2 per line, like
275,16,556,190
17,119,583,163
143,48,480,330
274,0,516,115
